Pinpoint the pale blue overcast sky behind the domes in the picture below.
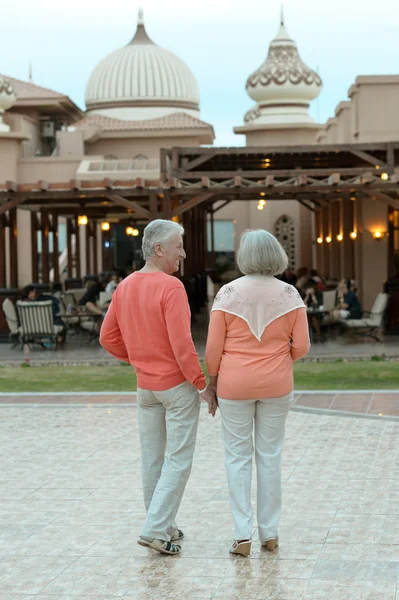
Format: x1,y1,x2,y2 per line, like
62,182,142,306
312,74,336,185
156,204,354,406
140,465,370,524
0,0,399,145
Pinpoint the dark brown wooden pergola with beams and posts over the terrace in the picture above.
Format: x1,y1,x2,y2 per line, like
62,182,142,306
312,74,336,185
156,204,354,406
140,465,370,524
0,142,399,288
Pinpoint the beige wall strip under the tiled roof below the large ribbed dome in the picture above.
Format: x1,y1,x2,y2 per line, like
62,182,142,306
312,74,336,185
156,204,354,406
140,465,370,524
86,137,199,159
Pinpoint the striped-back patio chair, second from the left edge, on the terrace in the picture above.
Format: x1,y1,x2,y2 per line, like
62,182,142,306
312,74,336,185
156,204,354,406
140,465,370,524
17,300,64,348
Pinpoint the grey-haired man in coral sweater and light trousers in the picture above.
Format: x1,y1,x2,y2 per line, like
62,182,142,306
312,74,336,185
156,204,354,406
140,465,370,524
100,219,217,554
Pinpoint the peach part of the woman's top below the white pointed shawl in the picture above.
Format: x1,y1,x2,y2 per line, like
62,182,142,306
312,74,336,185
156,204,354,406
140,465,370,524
205,308,310,400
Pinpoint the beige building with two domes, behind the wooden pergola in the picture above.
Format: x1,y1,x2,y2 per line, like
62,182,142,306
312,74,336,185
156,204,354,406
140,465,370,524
0,13,399,308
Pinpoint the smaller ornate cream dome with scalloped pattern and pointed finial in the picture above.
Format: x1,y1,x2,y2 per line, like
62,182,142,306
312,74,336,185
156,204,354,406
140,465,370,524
245,10,322,125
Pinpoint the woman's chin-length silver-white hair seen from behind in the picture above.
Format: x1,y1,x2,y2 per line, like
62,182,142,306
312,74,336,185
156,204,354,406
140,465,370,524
237,229,288,275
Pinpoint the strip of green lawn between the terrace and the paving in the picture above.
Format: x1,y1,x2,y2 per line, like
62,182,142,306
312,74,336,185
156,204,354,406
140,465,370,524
0,361,399,392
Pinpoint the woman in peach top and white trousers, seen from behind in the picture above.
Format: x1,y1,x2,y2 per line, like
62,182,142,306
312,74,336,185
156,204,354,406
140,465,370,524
206,229,310,556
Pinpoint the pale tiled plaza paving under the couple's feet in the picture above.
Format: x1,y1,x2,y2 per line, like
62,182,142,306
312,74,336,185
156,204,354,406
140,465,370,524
0,396,399,600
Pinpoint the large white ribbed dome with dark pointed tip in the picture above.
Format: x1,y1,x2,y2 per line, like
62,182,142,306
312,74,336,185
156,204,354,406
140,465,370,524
86,12,199,112
